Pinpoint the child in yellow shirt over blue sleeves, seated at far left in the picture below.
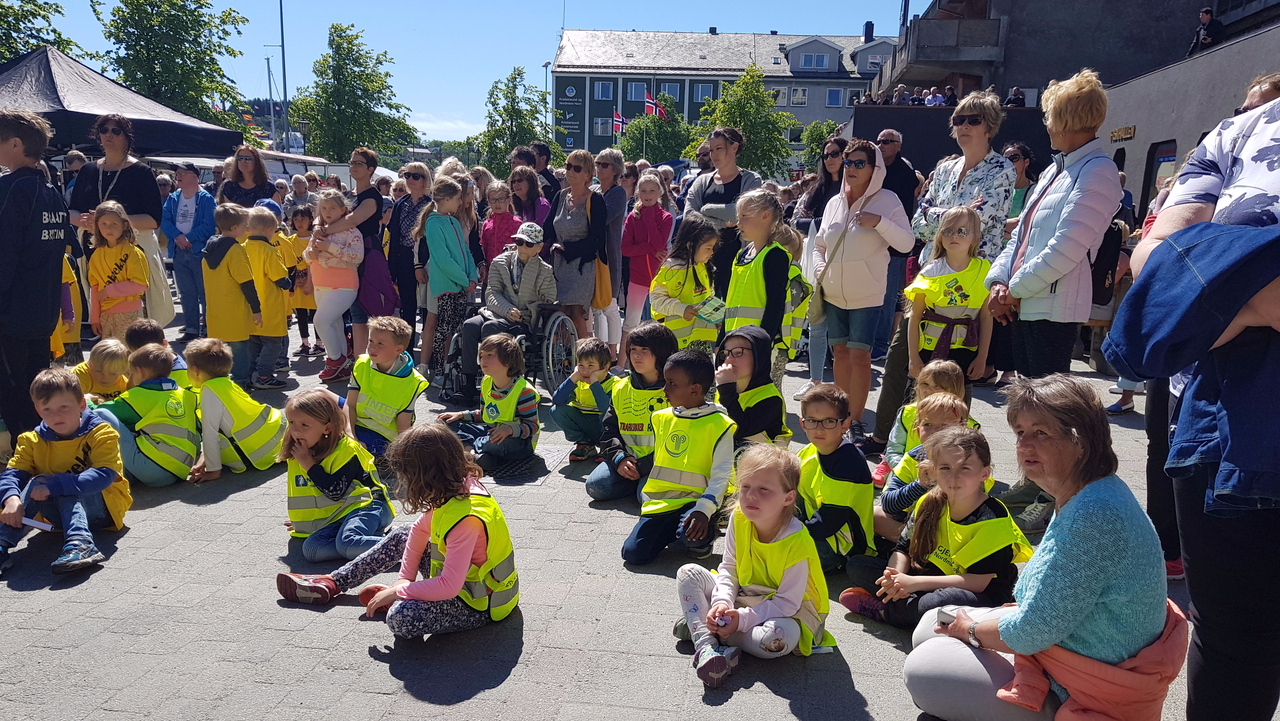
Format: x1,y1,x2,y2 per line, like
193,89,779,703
0,368,133,574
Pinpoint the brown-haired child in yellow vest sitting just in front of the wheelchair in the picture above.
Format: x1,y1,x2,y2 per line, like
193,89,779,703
439,333,540,473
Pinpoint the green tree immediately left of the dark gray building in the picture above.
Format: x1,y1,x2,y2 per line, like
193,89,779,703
467,68,564,178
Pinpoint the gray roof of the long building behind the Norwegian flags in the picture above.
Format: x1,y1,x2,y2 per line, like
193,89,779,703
552,29,897,77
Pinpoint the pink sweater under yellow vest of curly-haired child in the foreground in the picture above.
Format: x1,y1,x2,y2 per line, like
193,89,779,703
396,476,489,601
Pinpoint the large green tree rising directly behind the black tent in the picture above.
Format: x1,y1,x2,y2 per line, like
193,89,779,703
91,0,251,138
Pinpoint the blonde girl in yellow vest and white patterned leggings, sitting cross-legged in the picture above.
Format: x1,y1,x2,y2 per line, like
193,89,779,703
672,444,836,688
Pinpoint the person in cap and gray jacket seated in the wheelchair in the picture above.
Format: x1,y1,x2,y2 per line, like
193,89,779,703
458,223,556,401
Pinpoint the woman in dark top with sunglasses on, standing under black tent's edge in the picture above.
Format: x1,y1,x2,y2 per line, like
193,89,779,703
68,114,175,327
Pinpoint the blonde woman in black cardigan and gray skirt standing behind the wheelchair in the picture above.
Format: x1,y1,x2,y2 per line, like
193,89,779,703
543,149,609,338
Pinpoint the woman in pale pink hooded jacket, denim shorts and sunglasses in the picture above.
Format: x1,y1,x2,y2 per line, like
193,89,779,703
813,138,915,439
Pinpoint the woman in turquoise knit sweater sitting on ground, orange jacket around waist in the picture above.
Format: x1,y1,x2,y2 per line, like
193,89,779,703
902,374,1188,721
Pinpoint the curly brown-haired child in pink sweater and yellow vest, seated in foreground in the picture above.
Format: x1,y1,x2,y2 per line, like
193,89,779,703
275,424,520,638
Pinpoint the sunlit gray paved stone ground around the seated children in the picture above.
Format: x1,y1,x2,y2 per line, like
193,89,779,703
0,322,1208,721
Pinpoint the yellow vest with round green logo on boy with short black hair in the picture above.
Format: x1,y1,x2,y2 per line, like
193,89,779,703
640,409,737,516
